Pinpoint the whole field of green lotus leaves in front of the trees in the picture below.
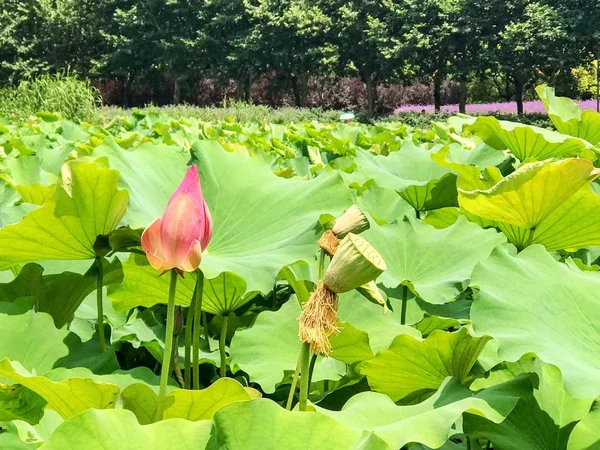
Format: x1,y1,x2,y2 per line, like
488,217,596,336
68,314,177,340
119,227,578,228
0,87,600,450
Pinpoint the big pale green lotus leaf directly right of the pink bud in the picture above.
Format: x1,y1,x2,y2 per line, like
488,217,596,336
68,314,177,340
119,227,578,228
195,144,352,292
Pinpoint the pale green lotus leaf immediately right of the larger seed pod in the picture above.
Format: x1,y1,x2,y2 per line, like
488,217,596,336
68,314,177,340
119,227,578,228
363,217,506,304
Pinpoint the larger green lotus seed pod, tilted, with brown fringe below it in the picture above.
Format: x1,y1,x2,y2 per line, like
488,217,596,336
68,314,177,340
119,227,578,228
325,233,386,294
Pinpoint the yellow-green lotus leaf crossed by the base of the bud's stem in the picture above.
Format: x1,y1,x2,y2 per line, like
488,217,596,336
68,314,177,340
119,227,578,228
122,378,252,425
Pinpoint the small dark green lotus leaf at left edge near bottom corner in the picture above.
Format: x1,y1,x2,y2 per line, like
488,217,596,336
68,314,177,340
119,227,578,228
0,384,46,424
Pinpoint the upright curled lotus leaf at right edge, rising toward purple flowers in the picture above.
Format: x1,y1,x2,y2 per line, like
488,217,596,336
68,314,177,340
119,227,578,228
535,85,600,145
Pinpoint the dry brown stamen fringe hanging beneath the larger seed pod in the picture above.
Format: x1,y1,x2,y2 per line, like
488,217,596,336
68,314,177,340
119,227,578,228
298,282,340,355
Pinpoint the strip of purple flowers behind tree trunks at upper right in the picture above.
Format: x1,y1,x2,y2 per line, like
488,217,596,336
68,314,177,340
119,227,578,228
394,100,596,114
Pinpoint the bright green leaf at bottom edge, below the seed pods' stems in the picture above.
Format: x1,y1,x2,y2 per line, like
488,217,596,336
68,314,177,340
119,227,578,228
214,399,391,450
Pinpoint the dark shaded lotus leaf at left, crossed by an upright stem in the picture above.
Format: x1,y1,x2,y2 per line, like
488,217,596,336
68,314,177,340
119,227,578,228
0,258,123,328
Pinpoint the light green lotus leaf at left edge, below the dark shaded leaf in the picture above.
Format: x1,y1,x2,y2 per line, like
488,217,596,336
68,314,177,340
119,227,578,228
0,301,69,380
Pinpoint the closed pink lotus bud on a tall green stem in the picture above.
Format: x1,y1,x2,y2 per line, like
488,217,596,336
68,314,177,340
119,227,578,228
142,165,212,272
